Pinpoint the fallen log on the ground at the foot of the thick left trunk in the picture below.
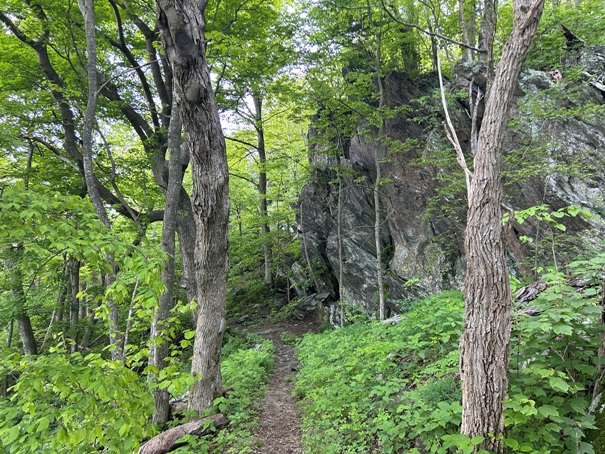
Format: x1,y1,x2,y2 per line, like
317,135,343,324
138,413,229,454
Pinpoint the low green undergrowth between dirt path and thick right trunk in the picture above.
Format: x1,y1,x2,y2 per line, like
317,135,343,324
295,292,463,454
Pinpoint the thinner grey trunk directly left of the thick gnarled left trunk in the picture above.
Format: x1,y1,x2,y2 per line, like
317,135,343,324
149,102,183,424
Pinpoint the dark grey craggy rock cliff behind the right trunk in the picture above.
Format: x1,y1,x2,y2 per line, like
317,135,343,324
298,48,605,315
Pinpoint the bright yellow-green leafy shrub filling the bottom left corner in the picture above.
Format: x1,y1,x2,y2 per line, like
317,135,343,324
0,351,153,454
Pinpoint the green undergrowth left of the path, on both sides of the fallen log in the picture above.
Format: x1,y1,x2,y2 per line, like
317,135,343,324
0,333,273,454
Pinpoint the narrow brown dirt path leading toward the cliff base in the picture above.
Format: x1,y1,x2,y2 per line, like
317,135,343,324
251,321,318,454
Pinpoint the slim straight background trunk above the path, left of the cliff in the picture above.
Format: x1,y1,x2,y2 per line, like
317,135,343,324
253,96,272,285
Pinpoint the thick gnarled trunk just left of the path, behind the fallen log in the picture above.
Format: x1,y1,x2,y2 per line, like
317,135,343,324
156,0,229,413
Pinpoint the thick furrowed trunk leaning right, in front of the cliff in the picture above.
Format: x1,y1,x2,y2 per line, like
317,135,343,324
460,0,543,452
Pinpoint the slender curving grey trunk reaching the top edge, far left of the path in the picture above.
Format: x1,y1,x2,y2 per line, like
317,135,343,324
78,0,123,361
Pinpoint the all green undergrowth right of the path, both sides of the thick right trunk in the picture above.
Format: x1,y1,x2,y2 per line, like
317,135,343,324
295,282,600,454
